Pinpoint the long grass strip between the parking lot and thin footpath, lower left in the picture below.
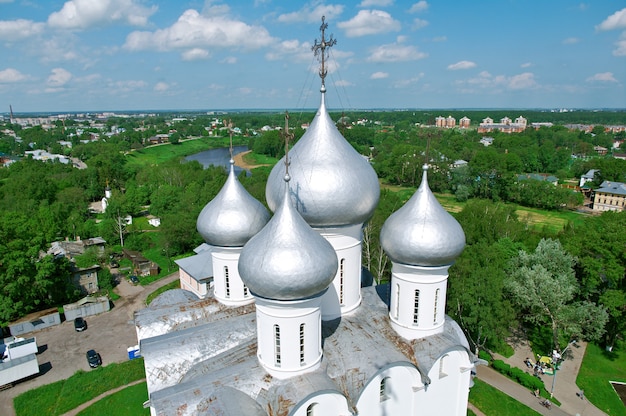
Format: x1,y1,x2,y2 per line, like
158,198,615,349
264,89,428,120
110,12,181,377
13,359,145,416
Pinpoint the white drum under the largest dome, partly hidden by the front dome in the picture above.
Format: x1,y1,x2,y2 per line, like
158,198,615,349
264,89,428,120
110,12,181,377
316,224,363,321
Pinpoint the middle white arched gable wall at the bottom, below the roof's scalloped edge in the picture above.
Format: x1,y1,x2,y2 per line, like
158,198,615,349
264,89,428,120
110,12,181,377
356,363,422,416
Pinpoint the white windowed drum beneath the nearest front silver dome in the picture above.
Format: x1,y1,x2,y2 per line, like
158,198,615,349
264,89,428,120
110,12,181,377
256,296,322,378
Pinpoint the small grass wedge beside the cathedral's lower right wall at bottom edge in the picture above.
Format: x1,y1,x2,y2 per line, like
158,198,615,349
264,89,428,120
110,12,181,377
469,378,539,416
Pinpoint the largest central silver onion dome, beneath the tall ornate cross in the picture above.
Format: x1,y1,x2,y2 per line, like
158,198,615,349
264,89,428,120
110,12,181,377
265,93,380,227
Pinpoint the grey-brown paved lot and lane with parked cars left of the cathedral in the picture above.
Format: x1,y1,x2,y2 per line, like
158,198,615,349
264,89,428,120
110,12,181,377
0,272,178,416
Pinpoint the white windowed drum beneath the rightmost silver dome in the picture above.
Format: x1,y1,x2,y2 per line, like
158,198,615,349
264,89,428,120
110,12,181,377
389,263,450,339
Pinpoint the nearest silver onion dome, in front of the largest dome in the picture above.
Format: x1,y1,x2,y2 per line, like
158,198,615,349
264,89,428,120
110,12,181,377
239,176,337,300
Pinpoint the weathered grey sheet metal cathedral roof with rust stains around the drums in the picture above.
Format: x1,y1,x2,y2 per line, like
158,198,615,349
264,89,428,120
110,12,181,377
142,285,473,415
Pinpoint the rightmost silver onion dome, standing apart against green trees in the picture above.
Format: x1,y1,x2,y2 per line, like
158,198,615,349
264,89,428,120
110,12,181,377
380,165,465,266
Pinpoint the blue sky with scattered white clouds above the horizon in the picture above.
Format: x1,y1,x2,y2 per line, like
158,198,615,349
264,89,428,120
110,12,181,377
0,0,626,112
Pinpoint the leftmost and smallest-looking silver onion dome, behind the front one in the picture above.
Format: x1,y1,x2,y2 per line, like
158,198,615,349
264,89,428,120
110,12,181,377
196,159,270,247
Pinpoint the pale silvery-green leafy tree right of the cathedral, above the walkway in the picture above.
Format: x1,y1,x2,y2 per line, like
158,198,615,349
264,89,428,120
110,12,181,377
505,239,608,352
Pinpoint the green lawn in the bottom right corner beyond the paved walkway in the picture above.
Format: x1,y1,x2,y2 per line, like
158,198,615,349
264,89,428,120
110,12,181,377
576,344,626,416
